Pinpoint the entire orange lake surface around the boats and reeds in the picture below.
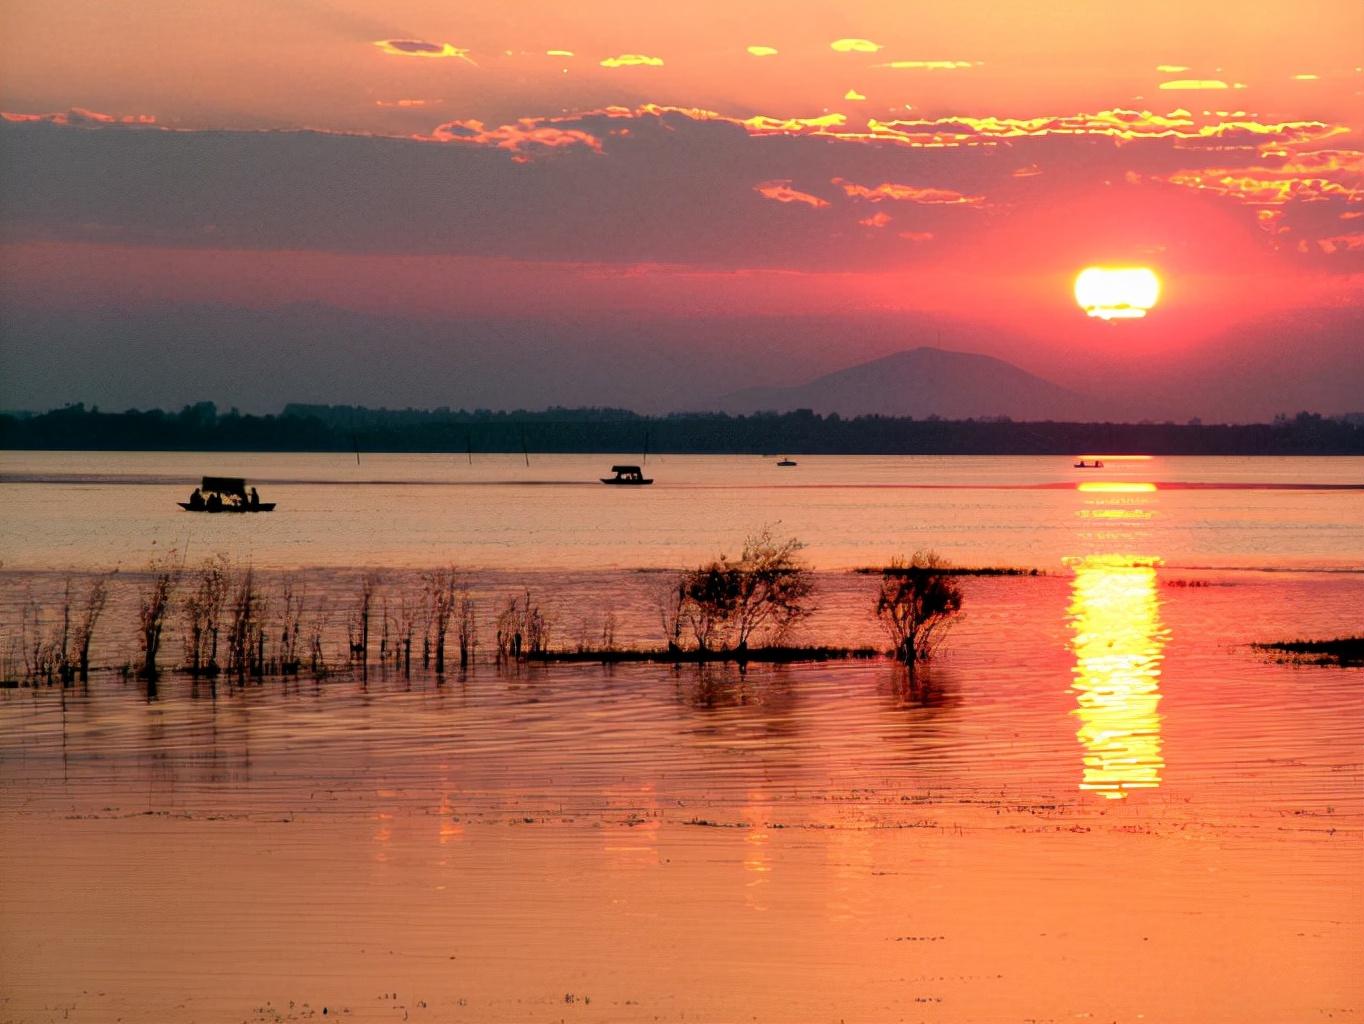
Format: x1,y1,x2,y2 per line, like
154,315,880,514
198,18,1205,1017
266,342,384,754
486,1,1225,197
0,454,1364,1023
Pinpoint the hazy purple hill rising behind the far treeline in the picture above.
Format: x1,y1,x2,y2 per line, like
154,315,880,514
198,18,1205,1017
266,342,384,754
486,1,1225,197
717,346,1094,420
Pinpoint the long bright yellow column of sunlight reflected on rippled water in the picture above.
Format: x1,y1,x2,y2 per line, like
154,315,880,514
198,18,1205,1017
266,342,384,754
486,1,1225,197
1068,555,1168,800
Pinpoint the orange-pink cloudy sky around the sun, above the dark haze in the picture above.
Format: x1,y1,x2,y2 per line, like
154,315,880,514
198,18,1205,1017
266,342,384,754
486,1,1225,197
0,0,1364,411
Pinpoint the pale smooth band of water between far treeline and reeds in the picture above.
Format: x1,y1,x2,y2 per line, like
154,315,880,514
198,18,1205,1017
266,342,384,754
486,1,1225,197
0,453,1364,570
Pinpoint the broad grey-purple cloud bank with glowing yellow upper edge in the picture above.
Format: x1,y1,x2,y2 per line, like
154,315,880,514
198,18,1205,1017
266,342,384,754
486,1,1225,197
0,105,1361,273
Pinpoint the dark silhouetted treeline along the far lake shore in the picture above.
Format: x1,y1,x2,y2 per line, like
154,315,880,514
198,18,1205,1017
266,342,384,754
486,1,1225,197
0,402,1364,455
